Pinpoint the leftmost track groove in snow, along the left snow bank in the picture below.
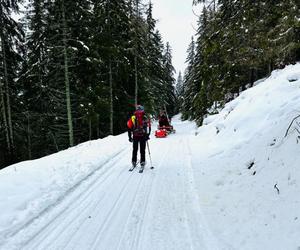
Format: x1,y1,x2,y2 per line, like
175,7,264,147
4,148,128,249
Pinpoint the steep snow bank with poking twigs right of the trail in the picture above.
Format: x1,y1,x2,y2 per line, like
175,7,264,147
192,64,300,249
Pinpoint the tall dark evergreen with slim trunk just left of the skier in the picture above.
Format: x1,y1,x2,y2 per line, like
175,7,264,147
93,0,132,134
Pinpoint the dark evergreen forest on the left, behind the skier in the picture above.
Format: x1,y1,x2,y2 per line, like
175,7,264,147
0,0,175,167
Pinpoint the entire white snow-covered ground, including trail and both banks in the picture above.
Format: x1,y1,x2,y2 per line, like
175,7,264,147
0,64,300,250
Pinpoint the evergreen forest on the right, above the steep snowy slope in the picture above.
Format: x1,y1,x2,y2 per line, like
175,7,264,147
177,0,300,126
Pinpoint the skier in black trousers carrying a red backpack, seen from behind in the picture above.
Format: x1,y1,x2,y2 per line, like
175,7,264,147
127,105,151,168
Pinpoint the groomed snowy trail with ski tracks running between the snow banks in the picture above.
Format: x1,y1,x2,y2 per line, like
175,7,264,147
4,117,218,250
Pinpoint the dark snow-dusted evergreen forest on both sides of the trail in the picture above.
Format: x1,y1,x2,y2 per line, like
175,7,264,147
0,0,300,168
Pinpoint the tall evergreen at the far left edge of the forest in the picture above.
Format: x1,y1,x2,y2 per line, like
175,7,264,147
0,0,23,166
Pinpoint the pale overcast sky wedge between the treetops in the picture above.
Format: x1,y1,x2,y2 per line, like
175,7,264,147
150,0,200,78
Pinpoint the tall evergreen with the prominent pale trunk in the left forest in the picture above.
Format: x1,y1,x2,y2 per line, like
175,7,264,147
46,0,91,149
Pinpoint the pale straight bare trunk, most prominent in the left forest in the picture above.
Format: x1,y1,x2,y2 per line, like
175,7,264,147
61,0,74,147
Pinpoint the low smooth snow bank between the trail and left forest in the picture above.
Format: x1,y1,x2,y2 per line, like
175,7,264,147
0,134,128,243
